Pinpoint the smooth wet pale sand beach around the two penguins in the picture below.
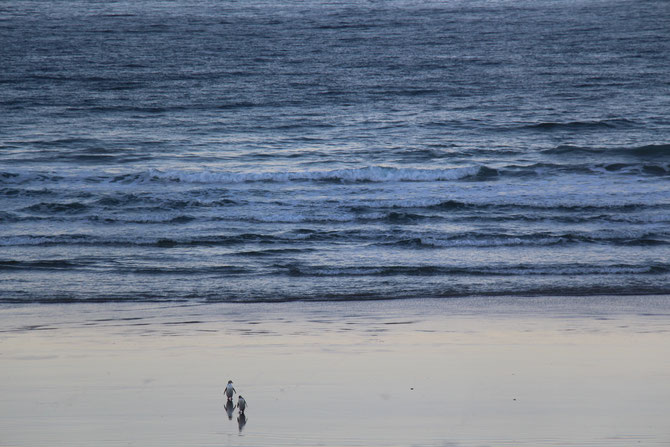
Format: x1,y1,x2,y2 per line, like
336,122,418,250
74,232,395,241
0,296,670,447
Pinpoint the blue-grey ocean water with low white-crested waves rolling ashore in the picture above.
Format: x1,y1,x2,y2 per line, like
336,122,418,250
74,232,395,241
0,0,670,303
